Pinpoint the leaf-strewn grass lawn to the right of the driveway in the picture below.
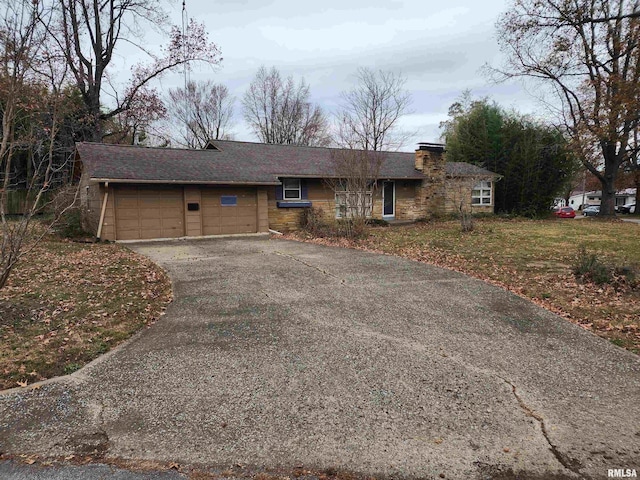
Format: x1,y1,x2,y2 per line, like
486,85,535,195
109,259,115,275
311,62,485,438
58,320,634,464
294,218,640,353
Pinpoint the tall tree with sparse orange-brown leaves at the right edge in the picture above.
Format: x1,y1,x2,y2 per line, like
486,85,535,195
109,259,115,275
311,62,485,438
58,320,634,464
497,0,640,216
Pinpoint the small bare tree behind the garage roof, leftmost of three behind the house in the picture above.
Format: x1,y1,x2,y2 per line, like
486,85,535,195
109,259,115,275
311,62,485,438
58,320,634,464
168,80,235,148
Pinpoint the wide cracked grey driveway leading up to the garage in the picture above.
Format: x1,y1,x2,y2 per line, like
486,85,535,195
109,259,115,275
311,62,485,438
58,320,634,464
0,237,640,479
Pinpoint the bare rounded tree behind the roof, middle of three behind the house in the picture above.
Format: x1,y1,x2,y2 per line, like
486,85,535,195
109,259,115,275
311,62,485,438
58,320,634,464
242,67,330,146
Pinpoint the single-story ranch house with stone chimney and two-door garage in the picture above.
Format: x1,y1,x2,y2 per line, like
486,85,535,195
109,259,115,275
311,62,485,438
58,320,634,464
76,140,498,241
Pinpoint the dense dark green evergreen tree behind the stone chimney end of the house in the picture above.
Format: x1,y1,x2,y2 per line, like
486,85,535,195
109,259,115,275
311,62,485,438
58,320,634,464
442,92,578,216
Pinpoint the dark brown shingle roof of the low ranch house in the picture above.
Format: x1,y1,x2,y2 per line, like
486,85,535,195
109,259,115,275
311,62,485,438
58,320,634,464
77,140,491,184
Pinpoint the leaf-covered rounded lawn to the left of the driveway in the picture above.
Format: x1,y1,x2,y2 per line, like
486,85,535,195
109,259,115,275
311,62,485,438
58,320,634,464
0,236,171,389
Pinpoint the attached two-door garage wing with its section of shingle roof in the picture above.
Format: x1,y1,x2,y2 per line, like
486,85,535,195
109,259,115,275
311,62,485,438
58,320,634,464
74,143,280,241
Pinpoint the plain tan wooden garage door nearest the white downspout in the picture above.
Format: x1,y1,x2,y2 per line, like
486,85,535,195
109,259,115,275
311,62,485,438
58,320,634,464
114,186,184,240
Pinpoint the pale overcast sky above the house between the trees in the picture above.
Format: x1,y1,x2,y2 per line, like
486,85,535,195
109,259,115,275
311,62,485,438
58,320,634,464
131,0,536,151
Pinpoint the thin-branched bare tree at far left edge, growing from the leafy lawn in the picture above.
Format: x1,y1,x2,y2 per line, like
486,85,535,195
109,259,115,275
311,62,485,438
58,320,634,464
0,0,77,289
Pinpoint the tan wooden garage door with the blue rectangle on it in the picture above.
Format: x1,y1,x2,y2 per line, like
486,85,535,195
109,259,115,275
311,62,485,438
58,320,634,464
201,187,258,235
